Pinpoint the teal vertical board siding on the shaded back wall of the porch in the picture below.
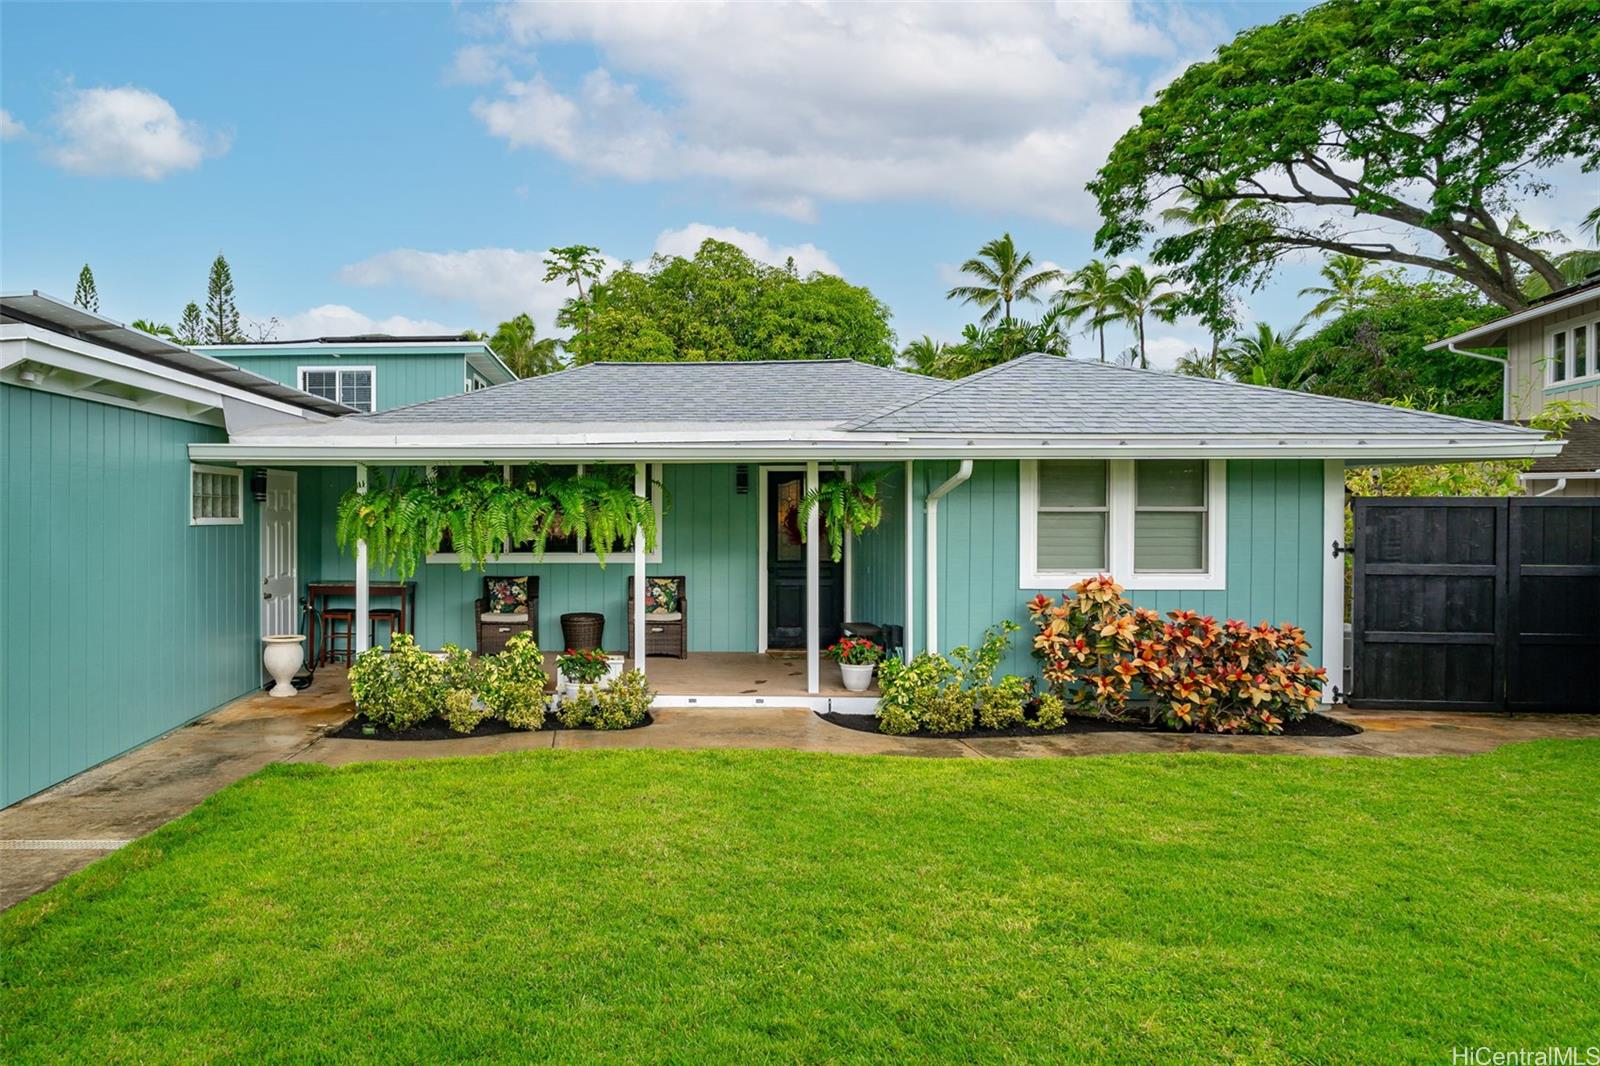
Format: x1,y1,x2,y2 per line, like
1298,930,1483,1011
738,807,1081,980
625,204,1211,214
299,463,760,651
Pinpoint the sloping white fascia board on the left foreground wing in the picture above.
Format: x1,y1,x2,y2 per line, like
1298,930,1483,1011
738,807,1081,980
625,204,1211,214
0,322,333,424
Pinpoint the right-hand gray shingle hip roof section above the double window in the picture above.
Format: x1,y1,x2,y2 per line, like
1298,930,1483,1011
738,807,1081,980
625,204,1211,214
845,354,1528,437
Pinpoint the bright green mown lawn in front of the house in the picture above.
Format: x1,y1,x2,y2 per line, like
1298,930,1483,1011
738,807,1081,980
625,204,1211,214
9,741,1600,1063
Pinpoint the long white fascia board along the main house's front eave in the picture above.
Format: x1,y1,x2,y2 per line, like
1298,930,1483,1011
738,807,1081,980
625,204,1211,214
190,435,1563,466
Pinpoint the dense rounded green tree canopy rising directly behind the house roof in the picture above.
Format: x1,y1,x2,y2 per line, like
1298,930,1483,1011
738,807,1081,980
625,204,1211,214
563,240,894,365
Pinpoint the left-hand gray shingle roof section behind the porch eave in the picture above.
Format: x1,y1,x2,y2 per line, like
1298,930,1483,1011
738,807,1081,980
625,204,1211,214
358,359,947,429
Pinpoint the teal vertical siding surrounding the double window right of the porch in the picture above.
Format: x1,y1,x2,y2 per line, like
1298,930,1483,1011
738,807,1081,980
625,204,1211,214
914,459,1339,675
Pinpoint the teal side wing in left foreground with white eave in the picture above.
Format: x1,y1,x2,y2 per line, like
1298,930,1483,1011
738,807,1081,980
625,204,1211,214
0,293,349,805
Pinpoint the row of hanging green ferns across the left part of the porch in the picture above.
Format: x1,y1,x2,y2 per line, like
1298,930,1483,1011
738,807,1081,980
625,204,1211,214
334,466,656,579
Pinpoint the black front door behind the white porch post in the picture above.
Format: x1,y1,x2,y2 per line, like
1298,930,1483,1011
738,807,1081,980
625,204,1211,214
765,471,845,648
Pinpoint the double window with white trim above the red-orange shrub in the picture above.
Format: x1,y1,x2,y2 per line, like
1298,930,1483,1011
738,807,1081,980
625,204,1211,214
1018,459,1227,589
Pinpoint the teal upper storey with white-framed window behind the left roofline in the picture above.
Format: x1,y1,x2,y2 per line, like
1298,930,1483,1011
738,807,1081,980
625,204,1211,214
194,333,517,411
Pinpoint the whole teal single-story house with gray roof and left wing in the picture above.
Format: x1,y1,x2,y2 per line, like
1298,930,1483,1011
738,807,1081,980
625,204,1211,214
0,286,1560,804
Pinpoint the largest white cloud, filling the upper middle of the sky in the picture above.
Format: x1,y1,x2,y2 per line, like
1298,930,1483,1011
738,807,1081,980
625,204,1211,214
458,2,1184,222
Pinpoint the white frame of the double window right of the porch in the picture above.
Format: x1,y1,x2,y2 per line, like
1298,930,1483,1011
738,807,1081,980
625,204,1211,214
1018,459,1227,591
